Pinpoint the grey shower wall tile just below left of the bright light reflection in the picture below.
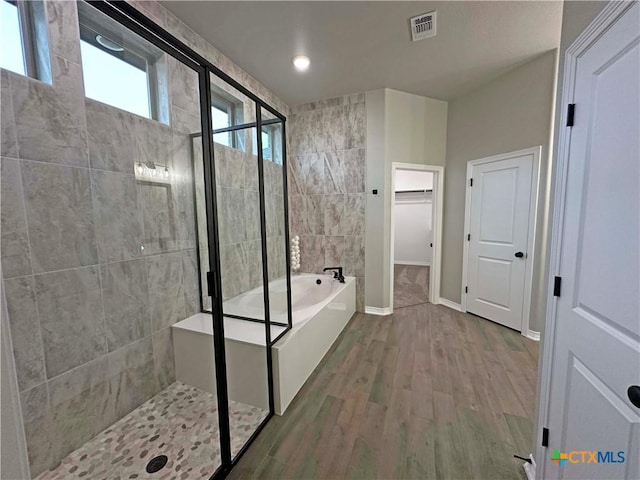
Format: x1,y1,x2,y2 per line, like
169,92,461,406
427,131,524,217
91,170,143,262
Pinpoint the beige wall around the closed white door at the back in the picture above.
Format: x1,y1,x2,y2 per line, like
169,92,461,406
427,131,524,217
441,50,557,331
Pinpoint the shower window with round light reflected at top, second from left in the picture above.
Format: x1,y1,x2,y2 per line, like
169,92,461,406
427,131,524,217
78,2,169,123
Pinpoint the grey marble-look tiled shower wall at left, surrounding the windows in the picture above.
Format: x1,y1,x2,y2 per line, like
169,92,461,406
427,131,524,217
0,1,286,476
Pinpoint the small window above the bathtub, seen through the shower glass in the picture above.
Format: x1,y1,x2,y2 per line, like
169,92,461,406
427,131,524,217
211,85,244,150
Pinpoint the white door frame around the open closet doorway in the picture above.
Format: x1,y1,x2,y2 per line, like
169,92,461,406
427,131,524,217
388,162,444,313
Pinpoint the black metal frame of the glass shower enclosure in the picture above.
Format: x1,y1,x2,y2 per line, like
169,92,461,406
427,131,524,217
87,0,292,480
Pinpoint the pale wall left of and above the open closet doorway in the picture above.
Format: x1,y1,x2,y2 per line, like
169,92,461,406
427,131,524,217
365,88,447,308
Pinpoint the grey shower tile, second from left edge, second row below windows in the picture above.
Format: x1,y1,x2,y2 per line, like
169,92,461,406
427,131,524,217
21,161,98,273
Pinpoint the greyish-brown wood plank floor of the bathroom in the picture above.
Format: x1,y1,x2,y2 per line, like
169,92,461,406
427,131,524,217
229,304,538,480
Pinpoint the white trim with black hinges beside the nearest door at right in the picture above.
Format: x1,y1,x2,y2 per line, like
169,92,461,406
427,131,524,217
534,2,635,480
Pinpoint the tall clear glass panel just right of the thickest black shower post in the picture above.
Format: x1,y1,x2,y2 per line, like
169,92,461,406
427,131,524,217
206,75,270,458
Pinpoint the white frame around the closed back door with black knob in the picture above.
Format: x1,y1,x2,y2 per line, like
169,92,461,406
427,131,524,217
460,145,542,340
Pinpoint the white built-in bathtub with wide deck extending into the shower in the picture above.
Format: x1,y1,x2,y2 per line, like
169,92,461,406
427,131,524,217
172,274,356,415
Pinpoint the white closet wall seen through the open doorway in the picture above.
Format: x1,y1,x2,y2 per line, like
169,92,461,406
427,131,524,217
393,170,433,265
